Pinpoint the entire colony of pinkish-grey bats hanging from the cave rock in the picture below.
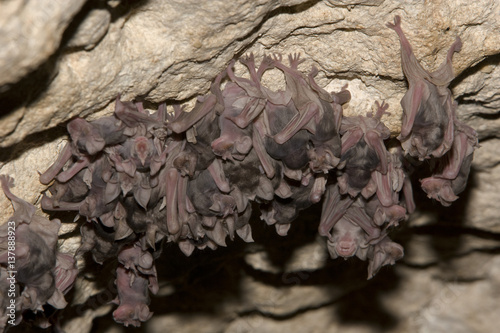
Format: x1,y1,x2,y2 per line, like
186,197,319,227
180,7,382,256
0,17,477,326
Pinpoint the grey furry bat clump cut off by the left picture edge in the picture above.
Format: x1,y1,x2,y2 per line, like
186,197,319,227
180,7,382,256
0,175,77,327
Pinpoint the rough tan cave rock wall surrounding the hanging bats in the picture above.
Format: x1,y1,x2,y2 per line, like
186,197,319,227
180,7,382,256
0,0,500,332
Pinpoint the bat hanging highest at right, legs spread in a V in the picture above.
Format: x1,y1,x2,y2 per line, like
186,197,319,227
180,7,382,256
387,16,462,160
